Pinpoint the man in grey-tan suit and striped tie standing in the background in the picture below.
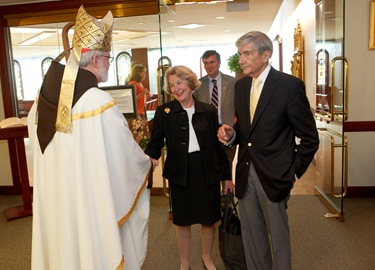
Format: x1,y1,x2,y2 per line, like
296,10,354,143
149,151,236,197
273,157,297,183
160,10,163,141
193,50,236,175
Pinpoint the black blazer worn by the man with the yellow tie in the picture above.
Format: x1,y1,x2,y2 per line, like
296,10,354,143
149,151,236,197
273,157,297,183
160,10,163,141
233,68,319,202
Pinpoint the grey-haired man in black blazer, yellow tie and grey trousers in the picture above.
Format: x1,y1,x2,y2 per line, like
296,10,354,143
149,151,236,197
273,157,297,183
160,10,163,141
218,31,319,270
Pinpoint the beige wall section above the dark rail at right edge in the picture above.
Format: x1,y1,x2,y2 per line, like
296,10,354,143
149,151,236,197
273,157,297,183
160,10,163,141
345,0,375,121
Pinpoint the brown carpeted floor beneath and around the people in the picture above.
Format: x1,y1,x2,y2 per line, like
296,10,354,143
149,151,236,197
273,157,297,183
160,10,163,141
0,191,375,270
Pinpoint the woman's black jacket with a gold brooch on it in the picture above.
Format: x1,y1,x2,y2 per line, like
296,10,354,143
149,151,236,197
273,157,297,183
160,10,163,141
145,100,232,185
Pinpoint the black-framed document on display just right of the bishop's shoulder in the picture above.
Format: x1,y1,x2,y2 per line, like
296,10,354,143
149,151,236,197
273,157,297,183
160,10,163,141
100,84,138,119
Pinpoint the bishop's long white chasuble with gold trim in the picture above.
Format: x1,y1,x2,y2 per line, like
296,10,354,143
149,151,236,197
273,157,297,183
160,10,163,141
28,88,151,270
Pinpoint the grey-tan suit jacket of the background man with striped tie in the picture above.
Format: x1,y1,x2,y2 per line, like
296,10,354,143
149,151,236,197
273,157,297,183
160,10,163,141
193,73,236,126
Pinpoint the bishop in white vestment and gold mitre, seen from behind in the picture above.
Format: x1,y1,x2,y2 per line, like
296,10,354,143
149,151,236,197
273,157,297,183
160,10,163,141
28,7,152,270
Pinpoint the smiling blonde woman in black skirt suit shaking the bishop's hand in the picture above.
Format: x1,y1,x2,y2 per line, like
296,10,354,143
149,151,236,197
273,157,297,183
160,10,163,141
145,66,234,270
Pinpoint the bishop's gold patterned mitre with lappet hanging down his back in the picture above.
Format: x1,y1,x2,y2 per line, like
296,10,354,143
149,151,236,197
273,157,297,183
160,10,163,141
56,6,113,133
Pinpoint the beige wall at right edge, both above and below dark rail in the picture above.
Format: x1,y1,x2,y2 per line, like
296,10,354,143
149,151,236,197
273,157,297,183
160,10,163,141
345,0,375,186
